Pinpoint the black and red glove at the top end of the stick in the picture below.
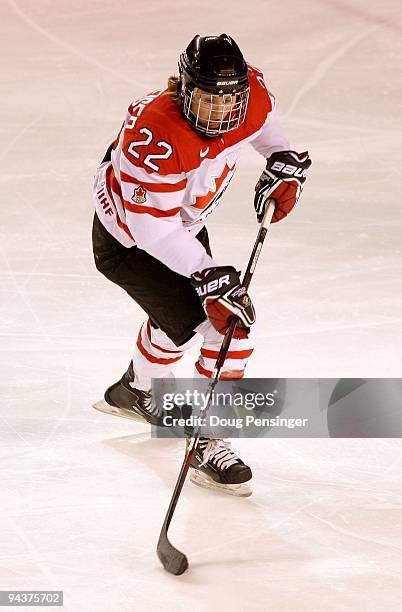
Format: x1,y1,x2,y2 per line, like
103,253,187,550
254,151,311,223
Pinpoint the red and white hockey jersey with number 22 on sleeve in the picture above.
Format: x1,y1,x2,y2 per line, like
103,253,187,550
94,66,289,277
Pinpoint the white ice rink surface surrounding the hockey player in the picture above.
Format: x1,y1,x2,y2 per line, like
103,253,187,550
0,0,402,612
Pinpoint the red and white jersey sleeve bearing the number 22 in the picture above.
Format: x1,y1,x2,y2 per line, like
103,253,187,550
116,122,216,277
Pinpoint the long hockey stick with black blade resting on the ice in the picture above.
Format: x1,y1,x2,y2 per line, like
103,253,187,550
156,200,275,576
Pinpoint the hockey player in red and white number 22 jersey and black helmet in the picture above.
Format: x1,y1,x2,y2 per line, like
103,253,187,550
93,34,311,494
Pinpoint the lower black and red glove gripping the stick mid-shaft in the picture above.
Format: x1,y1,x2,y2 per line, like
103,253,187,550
191,266,255,338
